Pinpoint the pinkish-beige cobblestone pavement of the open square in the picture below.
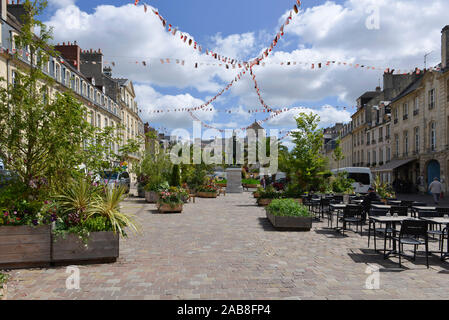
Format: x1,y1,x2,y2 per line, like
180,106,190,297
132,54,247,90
4,192,449,299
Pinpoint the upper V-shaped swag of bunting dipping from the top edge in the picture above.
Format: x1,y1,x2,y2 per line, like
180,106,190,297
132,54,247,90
134,0,301,69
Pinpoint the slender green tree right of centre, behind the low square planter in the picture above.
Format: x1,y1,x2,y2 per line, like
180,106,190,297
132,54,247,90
291,113,326,191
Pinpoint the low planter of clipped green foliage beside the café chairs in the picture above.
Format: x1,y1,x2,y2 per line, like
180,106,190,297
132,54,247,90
265,199,313,231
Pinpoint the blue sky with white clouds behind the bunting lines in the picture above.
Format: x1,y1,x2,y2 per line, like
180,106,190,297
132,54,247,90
41,0,449,145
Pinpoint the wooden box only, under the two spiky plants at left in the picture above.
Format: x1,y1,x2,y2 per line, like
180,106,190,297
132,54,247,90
52,231,120,264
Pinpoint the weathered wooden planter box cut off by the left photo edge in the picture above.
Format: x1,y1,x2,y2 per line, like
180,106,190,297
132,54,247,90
0,225,51,269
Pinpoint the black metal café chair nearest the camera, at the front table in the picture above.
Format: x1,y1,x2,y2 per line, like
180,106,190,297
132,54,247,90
395,220,429,269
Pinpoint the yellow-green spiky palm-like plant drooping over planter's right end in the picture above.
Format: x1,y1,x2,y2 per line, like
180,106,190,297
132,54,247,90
87,186,139,236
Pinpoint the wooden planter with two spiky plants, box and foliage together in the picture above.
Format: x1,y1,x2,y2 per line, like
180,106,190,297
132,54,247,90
50,179,138,264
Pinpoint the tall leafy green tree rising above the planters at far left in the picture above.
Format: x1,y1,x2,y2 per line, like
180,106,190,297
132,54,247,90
0,0,90,192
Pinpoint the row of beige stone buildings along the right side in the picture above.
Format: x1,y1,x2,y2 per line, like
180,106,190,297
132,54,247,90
324,26,449,192
